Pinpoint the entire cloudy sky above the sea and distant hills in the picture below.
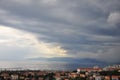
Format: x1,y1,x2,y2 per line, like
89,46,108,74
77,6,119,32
0,0,120,63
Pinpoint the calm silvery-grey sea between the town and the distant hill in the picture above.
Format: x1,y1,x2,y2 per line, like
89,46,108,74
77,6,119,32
0,61,104,70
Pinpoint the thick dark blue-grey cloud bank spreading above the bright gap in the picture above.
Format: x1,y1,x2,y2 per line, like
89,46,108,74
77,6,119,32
0,0,120,62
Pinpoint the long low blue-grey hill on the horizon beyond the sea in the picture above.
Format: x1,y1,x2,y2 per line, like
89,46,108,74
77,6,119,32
29,57,106,64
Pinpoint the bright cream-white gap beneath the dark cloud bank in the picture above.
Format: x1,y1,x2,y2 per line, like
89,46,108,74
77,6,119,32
0,25,67,60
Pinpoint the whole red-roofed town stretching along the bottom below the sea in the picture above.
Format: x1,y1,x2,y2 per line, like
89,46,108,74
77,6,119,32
0,65,120,80
